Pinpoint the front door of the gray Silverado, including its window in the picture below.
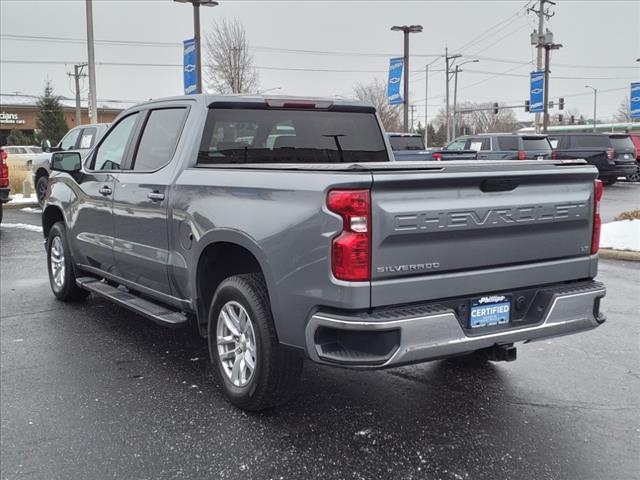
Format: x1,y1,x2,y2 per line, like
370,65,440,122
70,113,139,273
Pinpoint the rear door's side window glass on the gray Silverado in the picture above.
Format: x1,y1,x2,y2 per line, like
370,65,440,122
133,108,187,171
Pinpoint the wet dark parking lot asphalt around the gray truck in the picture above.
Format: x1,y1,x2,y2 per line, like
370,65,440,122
0,187,640,480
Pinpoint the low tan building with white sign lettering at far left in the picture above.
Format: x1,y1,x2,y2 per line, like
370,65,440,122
0,93,136,145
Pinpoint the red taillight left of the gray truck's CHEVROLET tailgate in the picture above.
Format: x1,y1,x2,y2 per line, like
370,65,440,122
327,190,371,282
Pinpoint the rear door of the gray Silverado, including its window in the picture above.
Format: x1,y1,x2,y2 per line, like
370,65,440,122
113,105,187,295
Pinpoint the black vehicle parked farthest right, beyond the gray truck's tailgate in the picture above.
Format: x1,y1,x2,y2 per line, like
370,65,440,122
549,132,637,185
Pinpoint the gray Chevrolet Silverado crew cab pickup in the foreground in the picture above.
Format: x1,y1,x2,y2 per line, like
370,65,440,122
42,95,605,410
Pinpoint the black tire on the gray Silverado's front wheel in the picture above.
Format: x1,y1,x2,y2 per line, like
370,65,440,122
47,222,89,302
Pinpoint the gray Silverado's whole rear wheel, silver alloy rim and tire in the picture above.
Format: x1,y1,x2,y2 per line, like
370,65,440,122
208,274,303,411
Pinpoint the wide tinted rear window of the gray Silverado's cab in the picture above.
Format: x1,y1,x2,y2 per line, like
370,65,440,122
198,108,389,163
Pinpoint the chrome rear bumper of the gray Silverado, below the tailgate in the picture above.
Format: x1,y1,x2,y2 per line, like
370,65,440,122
305,282,606,368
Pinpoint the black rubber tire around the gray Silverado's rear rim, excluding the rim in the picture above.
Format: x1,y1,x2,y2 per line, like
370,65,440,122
208,273,304,411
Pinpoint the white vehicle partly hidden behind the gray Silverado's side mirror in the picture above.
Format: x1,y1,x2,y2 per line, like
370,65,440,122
31,123,109,206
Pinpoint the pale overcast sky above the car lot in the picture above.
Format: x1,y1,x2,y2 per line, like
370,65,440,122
0,0,640,123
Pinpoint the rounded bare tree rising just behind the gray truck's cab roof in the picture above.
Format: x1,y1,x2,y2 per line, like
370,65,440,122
203,20,259,93
